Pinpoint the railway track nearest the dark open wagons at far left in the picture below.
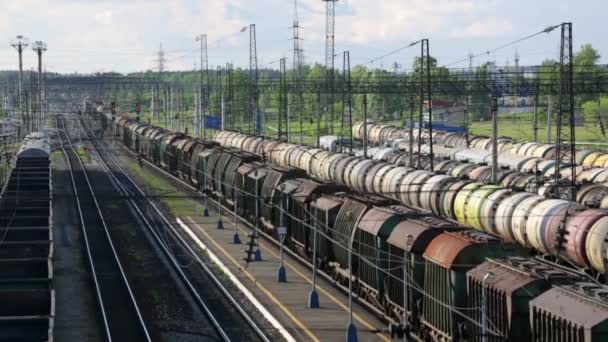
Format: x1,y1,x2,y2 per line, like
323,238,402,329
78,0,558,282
57,118,151,341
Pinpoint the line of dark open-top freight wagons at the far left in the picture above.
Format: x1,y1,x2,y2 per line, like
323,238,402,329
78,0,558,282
0,133,55,341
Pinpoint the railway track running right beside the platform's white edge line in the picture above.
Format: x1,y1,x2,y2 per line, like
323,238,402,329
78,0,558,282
80,115,270,341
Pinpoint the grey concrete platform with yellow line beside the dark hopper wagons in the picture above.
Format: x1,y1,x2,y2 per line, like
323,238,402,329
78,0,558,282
179,210,390,341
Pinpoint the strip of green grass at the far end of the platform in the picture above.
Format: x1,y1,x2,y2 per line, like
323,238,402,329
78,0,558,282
127,161,203,216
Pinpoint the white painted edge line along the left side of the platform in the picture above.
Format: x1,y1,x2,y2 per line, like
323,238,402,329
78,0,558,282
177,217,296,342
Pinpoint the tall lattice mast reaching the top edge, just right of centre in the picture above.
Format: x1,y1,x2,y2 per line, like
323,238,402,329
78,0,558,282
322,0,338,134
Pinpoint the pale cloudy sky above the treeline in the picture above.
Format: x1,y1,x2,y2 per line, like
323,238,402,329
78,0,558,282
0,0,608,73
